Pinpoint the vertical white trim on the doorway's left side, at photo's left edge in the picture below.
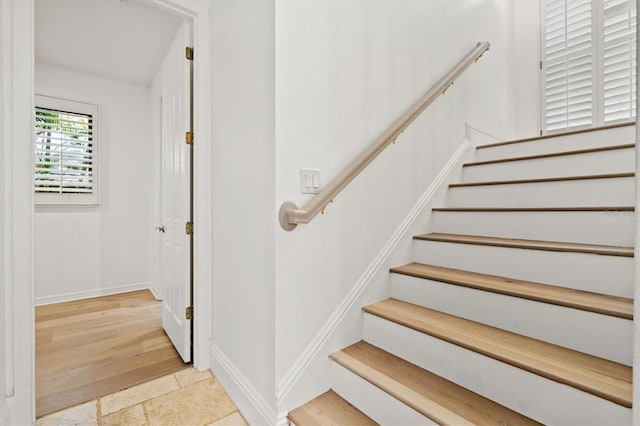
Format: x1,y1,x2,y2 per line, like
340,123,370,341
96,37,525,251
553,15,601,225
0,0,35,425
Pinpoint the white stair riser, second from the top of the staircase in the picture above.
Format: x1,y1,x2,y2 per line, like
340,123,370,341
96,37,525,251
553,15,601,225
462,148,635,182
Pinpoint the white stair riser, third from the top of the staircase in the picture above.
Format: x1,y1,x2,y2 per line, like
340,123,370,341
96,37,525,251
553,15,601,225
446,177,635,207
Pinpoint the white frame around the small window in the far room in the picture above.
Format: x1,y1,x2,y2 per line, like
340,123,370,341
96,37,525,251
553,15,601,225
31,94,100,208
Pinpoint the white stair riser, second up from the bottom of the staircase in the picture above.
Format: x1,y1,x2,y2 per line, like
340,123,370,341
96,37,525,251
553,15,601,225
364,314,631,425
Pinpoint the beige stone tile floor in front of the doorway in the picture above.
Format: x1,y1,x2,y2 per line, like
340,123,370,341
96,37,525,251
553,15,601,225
36,367,246,426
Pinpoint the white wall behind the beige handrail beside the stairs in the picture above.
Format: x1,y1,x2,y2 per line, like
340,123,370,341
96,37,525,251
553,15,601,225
275,0,532,410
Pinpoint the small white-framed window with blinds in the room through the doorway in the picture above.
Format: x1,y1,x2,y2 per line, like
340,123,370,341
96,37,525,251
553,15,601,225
33,96,98,205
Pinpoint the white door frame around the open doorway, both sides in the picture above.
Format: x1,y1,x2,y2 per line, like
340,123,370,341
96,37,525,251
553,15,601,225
0,0,212,424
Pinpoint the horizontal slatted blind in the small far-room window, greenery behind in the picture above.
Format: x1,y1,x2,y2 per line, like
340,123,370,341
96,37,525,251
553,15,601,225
34,107,95,194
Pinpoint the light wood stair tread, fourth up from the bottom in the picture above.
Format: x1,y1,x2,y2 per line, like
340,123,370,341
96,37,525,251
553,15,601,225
390,262,633,320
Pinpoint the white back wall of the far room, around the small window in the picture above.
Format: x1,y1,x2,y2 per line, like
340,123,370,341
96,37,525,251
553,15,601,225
35,64,154,303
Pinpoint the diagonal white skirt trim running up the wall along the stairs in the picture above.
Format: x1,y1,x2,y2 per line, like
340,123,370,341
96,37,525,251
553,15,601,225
276,140,471,408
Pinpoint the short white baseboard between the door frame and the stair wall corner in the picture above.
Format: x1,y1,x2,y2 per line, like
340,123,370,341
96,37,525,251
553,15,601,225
209,343,278,425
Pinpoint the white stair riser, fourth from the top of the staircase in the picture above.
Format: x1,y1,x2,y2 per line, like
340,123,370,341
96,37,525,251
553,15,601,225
432,211,635,247
